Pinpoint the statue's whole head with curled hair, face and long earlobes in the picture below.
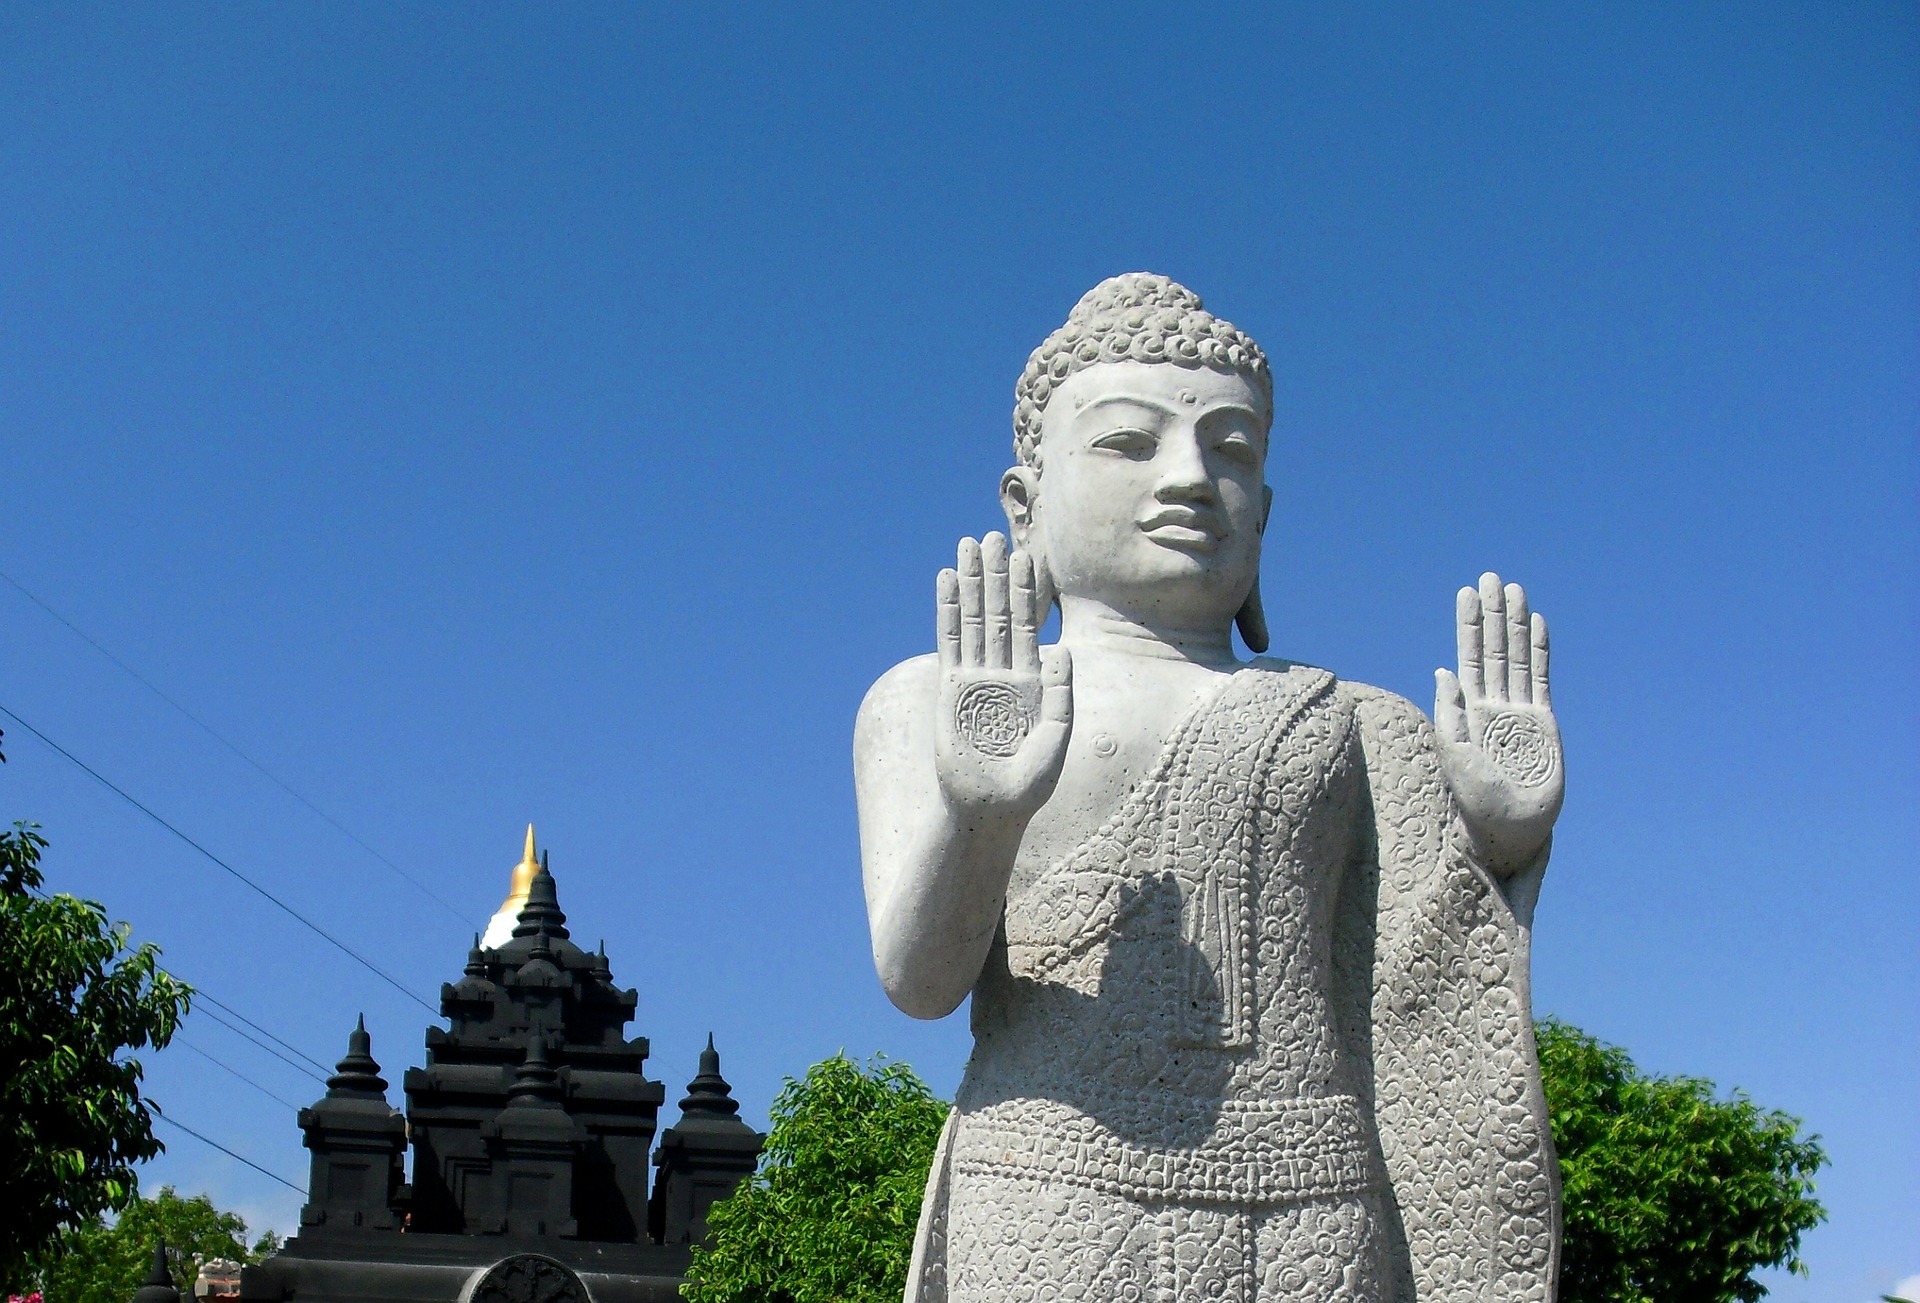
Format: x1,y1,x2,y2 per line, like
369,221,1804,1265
1000,272,1273,651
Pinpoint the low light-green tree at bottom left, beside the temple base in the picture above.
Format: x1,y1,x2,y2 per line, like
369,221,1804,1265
31,1186,280,1303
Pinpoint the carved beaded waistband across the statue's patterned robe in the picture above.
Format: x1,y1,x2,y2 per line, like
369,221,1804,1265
952,1096,1382,1203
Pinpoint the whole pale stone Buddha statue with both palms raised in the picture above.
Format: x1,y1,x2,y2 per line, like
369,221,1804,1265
854,274,1563,1303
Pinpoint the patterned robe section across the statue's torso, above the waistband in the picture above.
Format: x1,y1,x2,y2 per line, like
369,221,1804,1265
987,670,1361,1073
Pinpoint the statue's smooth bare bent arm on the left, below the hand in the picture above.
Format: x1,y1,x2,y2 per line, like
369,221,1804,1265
852,656,1029,1019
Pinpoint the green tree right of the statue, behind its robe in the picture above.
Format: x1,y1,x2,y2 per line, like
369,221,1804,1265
1538,1019,1826,1303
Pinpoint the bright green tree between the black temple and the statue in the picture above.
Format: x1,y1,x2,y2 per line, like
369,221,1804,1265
687,1055,947,1303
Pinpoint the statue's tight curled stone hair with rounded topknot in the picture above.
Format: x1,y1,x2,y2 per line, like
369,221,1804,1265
1014,271,1273,466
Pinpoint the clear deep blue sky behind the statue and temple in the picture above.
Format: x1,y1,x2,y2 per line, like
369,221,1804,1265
0,0,1920,1303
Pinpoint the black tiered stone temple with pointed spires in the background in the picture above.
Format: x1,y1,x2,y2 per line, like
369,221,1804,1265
240,829,764,1303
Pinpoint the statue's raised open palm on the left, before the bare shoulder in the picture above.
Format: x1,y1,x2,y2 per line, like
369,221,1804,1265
933,533,1073,817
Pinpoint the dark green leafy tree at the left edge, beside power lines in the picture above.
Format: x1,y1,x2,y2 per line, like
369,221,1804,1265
0,775,192,1280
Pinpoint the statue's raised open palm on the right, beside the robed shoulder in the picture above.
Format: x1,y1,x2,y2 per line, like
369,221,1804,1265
1434,572,1567,873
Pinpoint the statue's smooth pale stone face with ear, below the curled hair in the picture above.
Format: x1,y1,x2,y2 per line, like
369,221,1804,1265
1000,361,1269,628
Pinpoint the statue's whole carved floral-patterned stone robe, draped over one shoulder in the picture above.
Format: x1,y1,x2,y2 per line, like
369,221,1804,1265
906,660,1559,1303
